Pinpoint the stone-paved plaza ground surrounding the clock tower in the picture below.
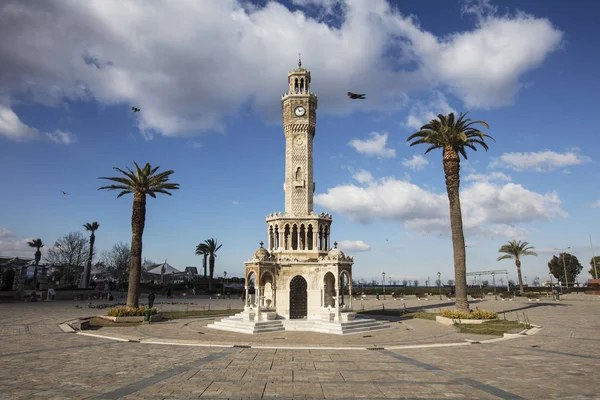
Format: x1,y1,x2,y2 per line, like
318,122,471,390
0,294,600,399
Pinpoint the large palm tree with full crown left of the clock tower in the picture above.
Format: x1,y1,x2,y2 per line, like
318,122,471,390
98,161,179,307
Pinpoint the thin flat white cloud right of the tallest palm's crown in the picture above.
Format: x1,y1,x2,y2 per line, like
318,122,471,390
489,150,591,172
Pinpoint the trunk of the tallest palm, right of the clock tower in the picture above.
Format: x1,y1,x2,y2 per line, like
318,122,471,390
443,147,469,311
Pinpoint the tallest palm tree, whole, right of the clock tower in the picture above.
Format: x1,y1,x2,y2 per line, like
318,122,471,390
406,113,494,311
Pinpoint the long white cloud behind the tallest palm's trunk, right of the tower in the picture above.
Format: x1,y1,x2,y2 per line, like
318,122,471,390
315,178,567,237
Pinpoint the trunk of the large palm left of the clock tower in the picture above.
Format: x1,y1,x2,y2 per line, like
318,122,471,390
127,193,146,307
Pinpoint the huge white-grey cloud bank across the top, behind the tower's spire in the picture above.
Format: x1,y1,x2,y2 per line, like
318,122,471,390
0,0,562,137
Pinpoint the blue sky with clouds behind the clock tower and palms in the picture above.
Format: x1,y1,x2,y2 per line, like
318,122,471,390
0,0,600,283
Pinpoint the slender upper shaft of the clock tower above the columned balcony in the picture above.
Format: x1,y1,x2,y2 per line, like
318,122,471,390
281,56,317,217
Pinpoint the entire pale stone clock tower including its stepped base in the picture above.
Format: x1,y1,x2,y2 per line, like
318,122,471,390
208,61,381,334
